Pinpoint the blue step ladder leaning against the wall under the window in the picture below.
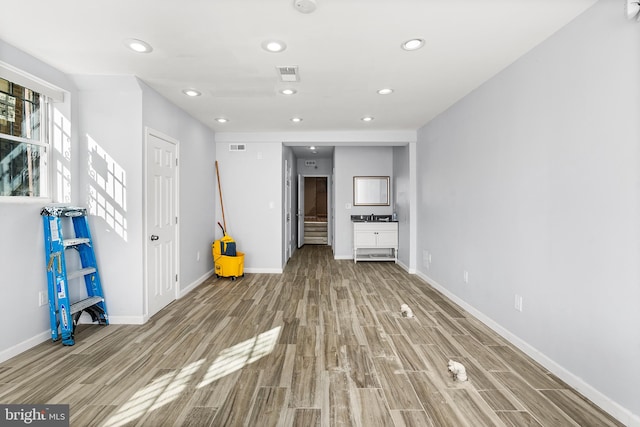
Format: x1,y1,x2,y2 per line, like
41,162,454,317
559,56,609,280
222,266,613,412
40,206,109,345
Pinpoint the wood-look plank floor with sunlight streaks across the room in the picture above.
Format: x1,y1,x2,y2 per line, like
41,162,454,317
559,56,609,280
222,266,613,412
0,246,621,427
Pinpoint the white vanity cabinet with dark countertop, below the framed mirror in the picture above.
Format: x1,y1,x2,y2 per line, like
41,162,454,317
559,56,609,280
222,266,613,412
353,221,398,263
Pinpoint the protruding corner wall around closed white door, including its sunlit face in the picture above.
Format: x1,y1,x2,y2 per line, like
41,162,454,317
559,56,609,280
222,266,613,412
74,76,215,323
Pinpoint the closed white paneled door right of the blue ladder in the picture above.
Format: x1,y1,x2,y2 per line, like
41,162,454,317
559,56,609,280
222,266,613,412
146,130,178,317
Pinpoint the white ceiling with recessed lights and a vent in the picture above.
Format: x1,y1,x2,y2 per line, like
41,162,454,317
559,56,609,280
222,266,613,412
0,0,596,132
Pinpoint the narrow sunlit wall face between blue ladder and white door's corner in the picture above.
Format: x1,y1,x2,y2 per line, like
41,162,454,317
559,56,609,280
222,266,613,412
74,76,144,323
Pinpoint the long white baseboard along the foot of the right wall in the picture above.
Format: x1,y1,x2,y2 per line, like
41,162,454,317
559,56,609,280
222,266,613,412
416,272,640,427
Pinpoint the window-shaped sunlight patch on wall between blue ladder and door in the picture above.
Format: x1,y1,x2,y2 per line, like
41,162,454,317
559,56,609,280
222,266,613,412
87,135,127,241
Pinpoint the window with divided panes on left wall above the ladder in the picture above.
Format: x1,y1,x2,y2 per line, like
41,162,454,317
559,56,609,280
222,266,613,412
0,77,48,197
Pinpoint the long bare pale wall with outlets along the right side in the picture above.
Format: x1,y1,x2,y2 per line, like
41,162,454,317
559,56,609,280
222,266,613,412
417,0,640,425
